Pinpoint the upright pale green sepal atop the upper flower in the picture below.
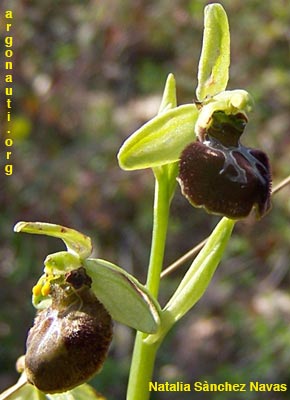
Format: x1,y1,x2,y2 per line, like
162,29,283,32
196,3,230,101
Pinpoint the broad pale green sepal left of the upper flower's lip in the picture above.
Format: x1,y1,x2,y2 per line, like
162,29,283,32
118,104,198,170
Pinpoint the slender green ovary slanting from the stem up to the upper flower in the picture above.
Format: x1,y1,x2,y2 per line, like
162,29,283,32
163,217,235,329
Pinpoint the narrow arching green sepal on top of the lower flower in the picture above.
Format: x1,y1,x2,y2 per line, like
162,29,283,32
14,221,92,259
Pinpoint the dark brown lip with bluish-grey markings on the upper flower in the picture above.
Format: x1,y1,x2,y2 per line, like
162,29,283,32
178,113,271,219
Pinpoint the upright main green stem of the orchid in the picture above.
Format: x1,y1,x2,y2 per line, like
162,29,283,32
127,168,171,400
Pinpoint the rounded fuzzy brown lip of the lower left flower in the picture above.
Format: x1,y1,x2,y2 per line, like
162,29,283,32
25,271,112,393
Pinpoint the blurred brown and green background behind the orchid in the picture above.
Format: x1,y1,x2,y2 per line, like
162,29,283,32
0,0,290,400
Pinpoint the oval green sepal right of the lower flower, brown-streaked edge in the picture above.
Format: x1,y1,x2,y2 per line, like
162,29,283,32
84,259,160,333
